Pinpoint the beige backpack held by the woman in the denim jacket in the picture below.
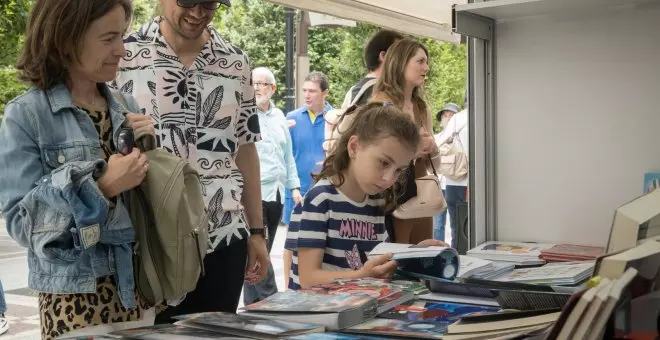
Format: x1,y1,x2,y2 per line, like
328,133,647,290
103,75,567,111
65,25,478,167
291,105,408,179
129,131,209,305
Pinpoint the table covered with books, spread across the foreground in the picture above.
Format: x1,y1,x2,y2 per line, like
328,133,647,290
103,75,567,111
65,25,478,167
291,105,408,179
65,240,660,340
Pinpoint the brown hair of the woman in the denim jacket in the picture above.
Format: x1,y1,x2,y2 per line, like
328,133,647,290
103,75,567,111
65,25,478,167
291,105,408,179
16,0,133,90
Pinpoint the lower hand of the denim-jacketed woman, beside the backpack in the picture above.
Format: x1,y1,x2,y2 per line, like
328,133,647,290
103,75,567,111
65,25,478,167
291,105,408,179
97,147,148,198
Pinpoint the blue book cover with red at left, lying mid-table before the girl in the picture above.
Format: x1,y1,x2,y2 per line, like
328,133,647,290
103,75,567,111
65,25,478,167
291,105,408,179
379,300,500,324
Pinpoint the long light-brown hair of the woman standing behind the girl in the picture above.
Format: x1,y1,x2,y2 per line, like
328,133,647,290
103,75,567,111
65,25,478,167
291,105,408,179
372,38,429,128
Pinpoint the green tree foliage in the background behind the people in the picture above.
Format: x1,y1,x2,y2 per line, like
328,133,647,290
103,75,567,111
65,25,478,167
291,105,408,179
0,0,467,126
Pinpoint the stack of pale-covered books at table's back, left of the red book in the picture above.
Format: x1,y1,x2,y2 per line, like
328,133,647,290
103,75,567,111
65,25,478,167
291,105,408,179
467,241,554,266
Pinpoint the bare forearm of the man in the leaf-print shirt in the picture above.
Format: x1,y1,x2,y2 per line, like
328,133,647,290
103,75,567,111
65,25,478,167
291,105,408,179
236,143,264,228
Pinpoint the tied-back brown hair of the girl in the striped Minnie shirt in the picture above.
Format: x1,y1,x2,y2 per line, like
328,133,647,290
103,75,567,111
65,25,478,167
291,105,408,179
314,103,420,211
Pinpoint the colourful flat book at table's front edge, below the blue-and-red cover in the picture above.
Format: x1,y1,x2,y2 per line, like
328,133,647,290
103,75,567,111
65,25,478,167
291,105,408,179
344,318,449,339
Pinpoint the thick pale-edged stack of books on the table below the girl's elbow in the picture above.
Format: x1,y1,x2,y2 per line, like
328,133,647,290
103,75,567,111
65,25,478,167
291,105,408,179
241,291,378,330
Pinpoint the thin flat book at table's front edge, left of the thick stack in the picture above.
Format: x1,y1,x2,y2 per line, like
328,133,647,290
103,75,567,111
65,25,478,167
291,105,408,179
174,312,325,339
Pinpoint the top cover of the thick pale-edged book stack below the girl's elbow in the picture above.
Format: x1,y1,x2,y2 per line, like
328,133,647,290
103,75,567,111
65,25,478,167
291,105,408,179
244,291,375,313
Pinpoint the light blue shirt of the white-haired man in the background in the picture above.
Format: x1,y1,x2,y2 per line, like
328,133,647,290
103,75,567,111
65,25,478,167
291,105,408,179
256,101,300,202
